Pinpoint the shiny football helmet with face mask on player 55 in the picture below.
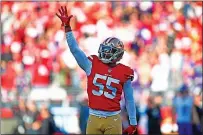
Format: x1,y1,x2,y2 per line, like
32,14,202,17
98,37,124,63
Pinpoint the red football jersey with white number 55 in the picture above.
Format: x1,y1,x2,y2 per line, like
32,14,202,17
87,55,134,111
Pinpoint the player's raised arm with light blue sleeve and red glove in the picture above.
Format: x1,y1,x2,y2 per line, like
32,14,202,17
56,7,92,75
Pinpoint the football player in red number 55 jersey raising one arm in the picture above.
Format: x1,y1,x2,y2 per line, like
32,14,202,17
56,7,137,134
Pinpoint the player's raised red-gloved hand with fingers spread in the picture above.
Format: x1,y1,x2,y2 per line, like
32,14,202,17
56,6,73,27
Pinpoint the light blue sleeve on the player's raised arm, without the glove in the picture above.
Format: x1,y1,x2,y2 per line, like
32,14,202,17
66,31,92,75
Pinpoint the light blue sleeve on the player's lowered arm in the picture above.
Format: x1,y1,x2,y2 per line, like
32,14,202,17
123,79,137,125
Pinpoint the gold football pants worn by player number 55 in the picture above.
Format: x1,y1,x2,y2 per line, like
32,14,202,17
86,114,122,135
